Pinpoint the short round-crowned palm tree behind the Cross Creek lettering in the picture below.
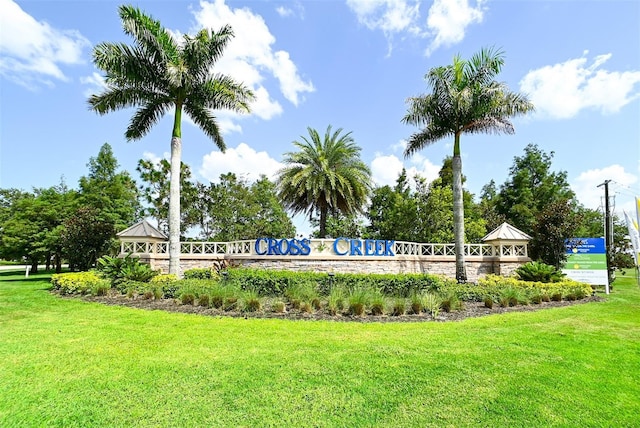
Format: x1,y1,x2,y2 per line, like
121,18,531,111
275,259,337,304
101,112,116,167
276,126,372,238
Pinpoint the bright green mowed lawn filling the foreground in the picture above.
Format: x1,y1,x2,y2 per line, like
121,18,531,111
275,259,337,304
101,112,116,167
0,272,640,427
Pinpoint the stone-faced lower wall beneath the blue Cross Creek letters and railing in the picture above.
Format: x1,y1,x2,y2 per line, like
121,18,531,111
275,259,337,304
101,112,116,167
146,254,530,282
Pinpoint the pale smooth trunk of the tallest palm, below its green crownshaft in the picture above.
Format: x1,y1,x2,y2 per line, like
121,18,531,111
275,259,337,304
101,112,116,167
169,136,182,277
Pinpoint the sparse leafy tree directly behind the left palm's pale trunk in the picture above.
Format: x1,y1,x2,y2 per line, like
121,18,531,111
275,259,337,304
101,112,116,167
136,159,199,234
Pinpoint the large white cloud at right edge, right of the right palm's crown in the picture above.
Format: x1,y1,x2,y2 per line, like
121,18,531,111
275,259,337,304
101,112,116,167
520,52,640,119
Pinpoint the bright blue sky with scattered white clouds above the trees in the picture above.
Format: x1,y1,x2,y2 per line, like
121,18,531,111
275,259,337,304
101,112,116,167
0,0,640,234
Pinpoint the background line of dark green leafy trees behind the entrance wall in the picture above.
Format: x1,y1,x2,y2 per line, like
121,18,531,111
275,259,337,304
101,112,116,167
0,140,632,271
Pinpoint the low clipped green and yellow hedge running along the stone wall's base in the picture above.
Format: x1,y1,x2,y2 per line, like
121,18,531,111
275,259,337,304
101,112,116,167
51,268,592,302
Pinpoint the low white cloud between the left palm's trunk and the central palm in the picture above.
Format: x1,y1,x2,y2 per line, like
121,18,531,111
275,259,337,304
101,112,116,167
199,143,283,182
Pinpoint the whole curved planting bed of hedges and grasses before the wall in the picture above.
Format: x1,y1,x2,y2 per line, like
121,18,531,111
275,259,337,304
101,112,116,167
52,260,592,318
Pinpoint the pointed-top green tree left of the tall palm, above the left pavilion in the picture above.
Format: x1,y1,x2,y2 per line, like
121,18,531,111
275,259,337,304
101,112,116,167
79,143,141,231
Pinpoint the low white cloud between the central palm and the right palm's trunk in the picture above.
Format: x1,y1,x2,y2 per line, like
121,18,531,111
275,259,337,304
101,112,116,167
371,154,440,186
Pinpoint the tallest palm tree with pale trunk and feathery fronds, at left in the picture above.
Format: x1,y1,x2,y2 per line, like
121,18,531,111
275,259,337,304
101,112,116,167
89,6,253,274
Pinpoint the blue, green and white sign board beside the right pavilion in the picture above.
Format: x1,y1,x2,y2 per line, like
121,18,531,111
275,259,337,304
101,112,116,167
562,238,609,286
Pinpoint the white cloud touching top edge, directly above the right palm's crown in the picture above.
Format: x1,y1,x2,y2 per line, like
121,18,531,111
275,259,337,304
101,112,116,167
427,0,484,55
